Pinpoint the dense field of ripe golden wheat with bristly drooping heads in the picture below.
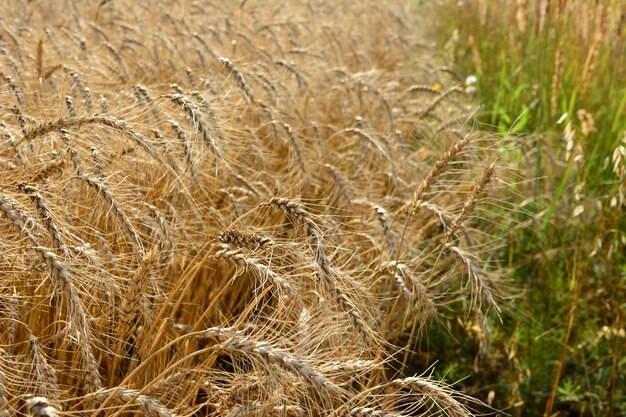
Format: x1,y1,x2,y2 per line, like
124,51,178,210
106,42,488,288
0,0,503,417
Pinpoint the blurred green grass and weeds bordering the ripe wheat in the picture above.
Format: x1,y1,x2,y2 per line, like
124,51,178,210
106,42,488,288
420,0,626,416
